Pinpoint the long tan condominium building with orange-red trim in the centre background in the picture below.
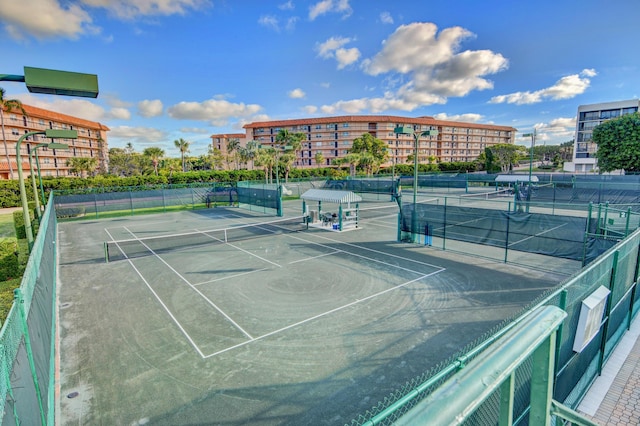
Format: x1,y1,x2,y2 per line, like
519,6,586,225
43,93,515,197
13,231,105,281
244,115,516,168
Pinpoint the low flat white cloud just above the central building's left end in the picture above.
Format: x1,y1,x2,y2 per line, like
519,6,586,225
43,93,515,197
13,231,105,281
167,99,262,126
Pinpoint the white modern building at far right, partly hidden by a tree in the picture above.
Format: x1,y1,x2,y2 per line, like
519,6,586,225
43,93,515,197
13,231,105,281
564,99,640,172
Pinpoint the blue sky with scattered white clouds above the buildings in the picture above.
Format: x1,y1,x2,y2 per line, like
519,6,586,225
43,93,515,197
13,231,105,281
0,0,640,157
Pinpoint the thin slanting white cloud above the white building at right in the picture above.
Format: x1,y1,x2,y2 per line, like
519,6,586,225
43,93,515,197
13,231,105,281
489,69,597,105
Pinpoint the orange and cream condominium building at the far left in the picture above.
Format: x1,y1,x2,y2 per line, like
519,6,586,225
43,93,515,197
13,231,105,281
0,104,109,179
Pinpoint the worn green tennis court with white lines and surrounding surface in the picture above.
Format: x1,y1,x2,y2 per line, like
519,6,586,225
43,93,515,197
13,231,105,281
58,202,564,425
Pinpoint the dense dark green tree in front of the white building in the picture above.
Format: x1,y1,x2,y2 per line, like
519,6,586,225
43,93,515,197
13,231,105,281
592,112,640,173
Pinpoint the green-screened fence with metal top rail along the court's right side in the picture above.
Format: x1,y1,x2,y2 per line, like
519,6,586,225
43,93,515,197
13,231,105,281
350,226,640,426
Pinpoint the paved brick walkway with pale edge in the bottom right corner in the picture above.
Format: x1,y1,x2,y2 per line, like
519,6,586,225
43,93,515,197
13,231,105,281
578,317,640,426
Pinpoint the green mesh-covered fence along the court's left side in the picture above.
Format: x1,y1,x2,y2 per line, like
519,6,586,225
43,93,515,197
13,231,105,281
0,195,57,425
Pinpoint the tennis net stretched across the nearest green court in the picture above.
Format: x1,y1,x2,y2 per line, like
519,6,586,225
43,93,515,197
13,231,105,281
104,216,308,262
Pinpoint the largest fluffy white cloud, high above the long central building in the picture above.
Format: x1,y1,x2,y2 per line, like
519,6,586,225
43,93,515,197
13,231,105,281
316,23,508,114
